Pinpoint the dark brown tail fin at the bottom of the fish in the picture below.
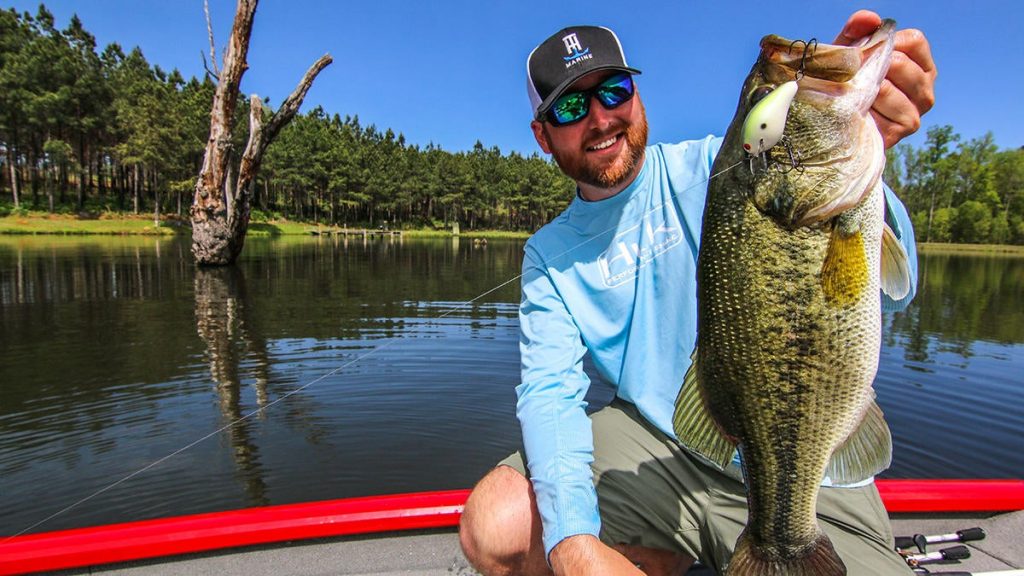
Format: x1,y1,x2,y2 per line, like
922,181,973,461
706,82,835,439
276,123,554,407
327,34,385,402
725,530,846,576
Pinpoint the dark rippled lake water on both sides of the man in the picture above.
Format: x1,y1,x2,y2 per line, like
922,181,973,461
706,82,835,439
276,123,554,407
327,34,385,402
0,238,1024,535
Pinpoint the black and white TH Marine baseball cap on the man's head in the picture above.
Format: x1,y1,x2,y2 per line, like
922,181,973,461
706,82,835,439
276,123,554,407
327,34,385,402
526,26,640,120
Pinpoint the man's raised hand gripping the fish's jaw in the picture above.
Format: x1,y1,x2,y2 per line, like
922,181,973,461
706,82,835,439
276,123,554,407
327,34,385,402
834,10,937,149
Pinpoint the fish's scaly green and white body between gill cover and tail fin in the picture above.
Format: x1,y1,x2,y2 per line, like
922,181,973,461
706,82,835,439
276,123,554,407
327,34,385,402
697,181,882,574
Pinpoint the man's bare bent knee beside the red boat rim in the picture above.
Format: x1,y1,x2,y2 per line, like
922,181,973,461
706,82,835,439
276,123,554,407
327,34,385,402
459,466,547,574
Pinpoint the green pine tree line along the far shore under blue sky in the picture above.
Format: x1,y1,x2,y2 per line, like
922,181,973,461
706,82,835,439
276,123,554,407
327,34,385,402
0,5,1024,244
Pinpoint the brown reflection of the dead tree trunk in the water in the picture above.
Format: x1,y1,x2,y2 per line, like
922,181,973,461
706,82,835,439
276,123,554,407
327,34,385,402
195,266,270,505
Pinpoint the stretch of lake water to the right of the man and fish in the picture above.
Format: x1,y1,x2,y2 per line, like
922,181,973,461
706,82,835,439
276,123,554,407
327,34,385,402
874,253,1024,478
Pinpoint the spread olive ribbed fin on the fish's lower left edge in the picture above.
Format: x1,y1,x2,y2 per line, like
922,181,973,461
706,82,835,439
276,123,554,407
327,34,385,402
672,348,736,469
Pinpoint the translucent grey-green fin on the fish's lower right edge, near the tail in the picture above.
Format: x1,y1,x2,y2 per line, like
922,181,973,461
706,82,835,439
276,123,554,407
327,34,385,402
825,400,893,484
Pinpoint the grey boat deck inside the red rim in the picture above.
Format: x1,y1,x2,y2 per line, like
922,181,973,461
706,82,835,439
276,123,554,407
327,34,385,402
54,510,1024,576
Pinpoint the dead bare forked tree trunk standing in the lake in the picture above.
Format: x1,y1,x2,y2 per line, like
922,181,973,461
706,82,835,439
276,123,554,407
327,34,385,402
191,0,333,265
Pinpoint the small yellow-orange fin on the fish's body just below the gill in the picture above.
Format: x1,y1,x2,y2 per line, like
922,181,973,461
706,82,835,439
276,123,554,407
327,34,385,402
821,220,868,306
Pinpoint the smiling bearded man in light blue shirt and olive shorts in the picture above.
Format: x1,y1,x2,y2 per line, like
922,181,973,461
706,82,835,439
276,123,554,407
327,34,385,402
460,11,935,575
